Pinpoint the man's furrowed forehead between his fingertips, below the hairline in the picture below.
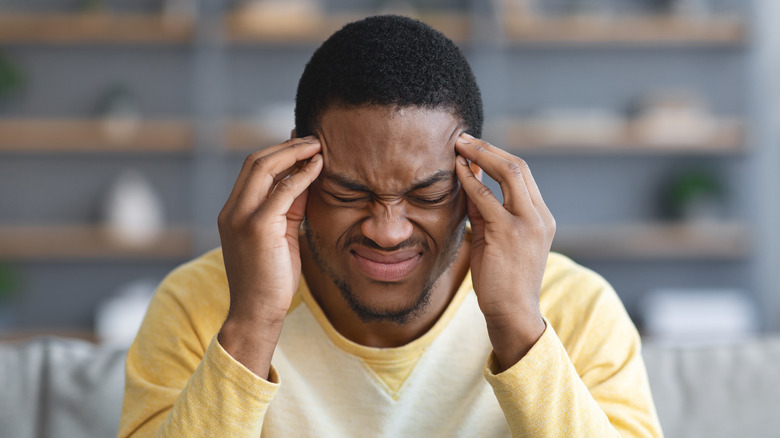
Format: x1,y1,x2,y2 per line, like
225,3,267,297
318,106,463,190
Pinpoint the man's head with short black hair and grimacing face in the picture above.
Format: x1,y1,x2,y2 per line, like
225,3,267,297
296,16,482,323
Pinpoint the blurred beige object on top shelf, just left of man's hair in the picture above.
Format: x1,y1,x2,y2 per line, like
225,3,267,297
236,0,322,37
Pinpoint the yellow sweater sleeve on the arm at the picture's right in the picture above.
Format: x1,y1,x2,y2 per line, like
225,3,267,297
484,255,662,437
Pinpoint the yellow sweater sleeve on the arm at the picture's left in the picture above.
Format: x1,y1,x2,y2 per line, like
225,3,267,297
118,252,279,437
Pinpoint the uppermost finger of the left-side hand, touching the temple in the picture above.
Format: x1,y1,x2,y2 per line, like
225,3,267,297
236,137,321,212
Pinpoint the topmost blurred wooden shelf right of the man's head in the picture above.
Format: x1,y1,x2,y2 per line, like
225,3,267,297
503,15,745,47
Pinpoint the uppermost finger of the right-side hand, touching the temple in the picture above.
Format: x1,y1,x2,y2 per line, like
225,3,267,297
455,135,535,214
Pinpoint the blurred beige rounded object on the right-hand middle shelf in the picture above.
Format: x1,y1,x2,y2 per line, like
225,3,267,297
633,92,715,147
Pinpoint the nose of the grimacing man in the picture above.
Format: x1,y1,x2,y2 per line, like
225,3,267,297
361,201,413,248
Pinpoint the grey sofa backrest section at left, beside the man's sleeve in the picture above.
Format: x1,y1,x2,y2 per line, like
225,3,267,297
0,338,127,438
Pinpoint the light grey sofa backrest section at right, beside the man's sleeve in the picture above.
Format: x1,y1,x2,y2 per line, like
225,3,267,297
643,335,780,438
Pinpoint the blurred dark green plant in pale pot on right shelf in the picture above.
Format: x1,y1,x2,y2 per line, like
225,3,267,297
662,168,726,224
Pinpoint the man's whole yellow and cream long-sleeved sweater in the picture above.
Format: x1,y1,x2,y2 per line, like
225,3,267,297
119,250,661,438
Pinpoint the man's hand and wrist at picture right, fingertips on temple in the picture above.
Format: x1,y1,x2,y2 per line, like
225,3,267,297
455,133,555,371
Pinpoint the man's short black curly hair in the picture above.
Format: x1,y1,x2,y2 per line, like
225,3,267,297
295,15,483,137
